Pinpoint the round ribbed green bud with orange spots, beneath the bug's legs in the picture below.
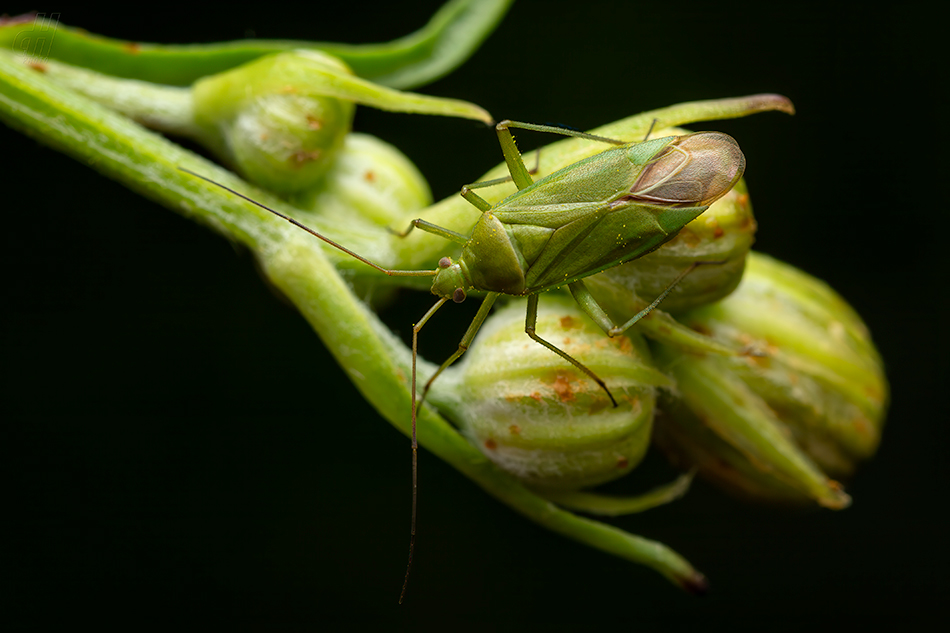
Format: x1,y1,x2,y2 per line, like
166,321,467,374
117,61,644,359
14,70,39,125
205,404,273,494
432,293,670,490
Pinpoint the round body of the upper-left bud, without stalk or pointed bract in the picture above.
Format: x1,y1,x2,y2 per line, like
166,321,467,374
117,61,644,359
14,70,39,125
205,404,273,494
193,51,356,193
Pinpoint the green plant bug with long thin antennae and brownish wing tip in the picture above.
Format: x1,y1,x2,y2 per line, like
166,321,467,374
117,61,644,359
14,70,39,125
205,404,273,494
182,121,745,602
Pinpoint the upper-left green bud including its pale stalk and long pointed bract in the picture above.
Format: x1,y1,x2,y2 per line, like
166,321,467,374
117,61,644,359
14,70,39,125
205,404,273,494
11,50,492,198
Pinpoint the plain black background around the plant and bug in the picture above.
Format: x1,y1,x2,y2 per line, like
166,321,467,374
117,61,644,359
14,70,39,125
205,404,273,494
0,0,950,630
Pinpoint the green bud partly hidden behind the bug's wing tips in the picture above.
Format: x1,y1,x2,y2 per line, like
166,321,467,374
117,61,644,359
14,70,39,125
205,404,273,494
585,180,756,319
